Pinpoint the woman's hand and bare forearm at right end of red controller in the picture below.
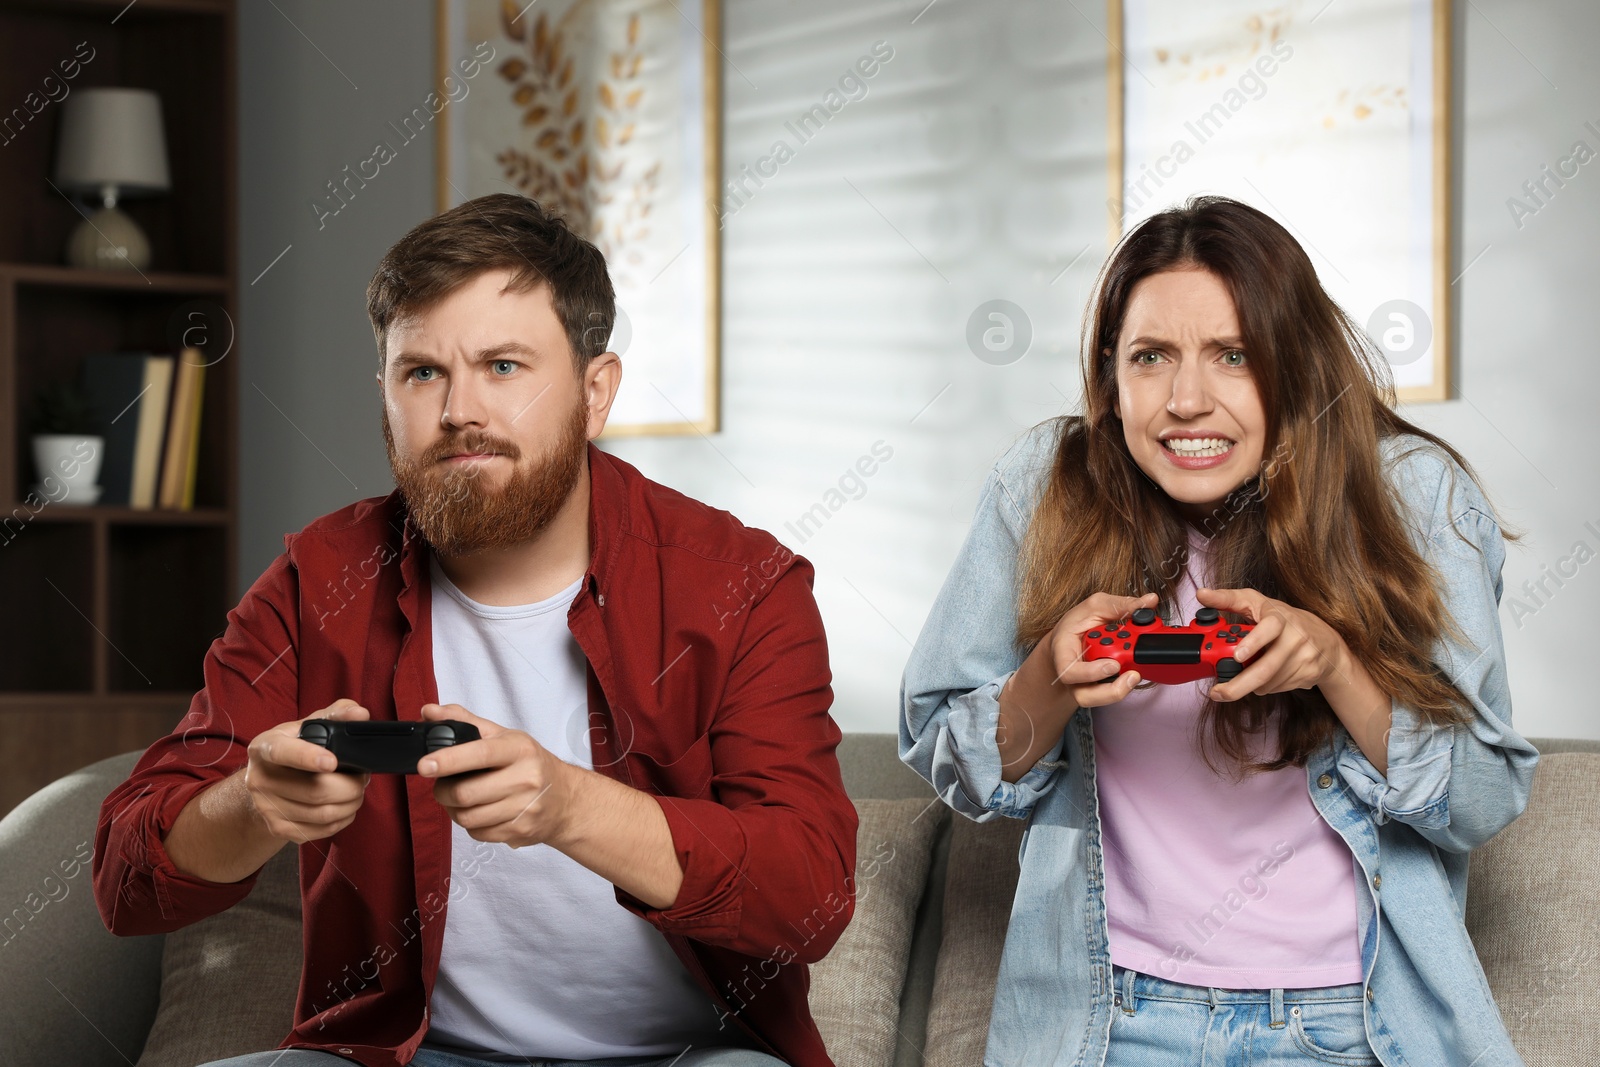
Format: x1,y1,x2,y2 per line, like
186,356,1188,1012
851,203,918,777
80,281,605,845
1195,589,1394,774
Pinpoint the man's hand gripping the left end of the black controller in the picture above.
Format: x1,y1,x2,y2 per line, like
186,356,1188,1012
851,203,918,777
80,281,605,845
245,697,371,845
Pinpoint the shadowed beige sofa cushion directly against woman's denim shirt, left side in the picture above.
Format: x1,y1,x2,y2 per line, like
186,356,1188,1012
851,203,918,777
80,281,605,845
925,817,1027,1067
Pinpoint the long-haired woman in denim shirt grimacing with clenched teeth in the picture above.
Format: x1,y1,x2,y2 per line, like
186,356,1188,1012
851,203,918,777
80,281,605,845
901,197,1538,1067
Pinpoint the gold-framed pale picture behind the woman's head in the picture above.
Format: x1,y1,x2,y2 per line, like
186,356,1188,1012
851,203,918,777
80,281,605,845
1107,0,1452,402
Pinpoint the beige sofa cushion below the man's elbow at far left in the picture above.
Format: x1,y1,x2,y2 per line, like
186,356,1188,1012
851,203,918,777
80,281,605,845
138,848,301,1067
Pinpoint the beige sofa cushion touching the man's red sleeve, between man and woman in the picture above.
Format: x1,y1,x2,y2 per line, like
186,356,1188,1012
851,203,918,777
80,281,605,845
810,797,949,1067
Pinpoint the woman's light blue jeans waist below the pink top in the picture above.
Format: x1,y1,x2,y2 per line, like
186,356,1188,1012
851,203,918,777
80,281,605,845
1106,966,1378,1067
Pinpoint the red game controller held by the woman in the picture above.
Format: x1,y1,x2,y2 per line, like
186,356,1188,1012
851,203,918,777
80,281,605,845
1083,608,1254,685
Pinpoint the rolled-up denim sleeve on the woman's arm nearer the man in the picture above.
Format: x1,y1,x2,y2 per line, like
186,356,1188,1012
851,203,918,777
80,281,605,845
899,424,1066,822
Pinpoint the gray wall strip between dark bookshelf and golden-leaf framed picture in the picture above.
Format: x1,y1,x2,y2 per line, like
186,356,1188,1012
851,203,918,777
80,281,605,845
238,0,434,559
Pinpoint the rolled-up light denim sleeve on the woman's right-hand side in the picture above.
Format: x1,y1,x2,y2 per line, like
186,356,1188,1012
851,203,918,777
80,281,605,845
1336,453,1539,853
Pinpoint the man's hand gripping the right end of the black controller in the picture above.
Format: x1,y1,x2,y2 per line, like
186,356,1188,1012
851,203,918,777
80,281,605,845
416,704,578,848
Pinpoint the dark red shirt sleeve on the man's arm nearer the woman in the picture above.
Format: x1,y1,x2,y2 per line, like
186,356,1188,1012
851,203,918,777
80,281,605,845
618,557,856,963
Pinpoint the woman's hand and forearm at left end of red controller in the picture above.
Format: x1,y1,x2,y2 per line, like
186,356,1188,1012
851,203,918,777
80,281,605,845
995,593,1158,782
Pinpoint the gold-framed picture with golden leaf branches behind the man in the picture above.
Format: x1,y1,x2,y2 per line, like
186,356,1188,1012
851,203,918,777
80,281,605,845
435,0,722,437
